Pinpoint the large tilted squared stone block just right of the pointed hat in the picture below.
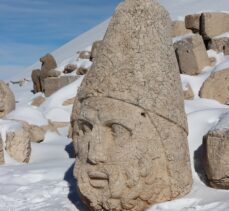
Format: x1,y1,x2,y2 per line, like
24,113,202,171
175,34,210,75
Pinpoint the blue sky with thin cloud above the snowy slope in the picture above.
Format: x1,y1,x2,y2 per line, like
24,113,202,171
0,0,121,70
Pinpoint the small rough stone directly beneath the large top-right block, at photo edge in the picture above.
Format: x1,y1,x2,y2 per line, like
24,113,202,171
208,37,229,55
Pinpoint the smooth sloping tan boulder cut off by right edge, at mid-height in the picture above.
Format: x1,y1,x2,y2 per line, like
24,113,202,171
200,69,229,105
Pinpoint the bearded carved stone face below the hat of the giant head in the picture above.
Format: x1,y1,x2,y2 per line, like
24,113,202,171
74,97,168,210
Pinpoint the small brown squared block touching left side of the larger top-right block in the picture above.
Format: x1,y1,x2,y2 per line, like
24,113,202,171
185,14,201,33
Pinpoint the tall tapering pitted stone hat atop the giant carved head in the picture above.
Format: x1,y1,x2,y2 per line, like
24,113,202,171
78,0,187,131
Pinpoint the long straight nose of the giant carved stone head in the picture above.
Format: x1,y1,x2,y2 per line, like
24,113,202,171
88,127,108,165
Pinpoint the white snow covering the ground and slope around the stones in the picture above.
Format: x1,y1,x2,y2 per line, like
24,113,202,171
0,0,229,211
